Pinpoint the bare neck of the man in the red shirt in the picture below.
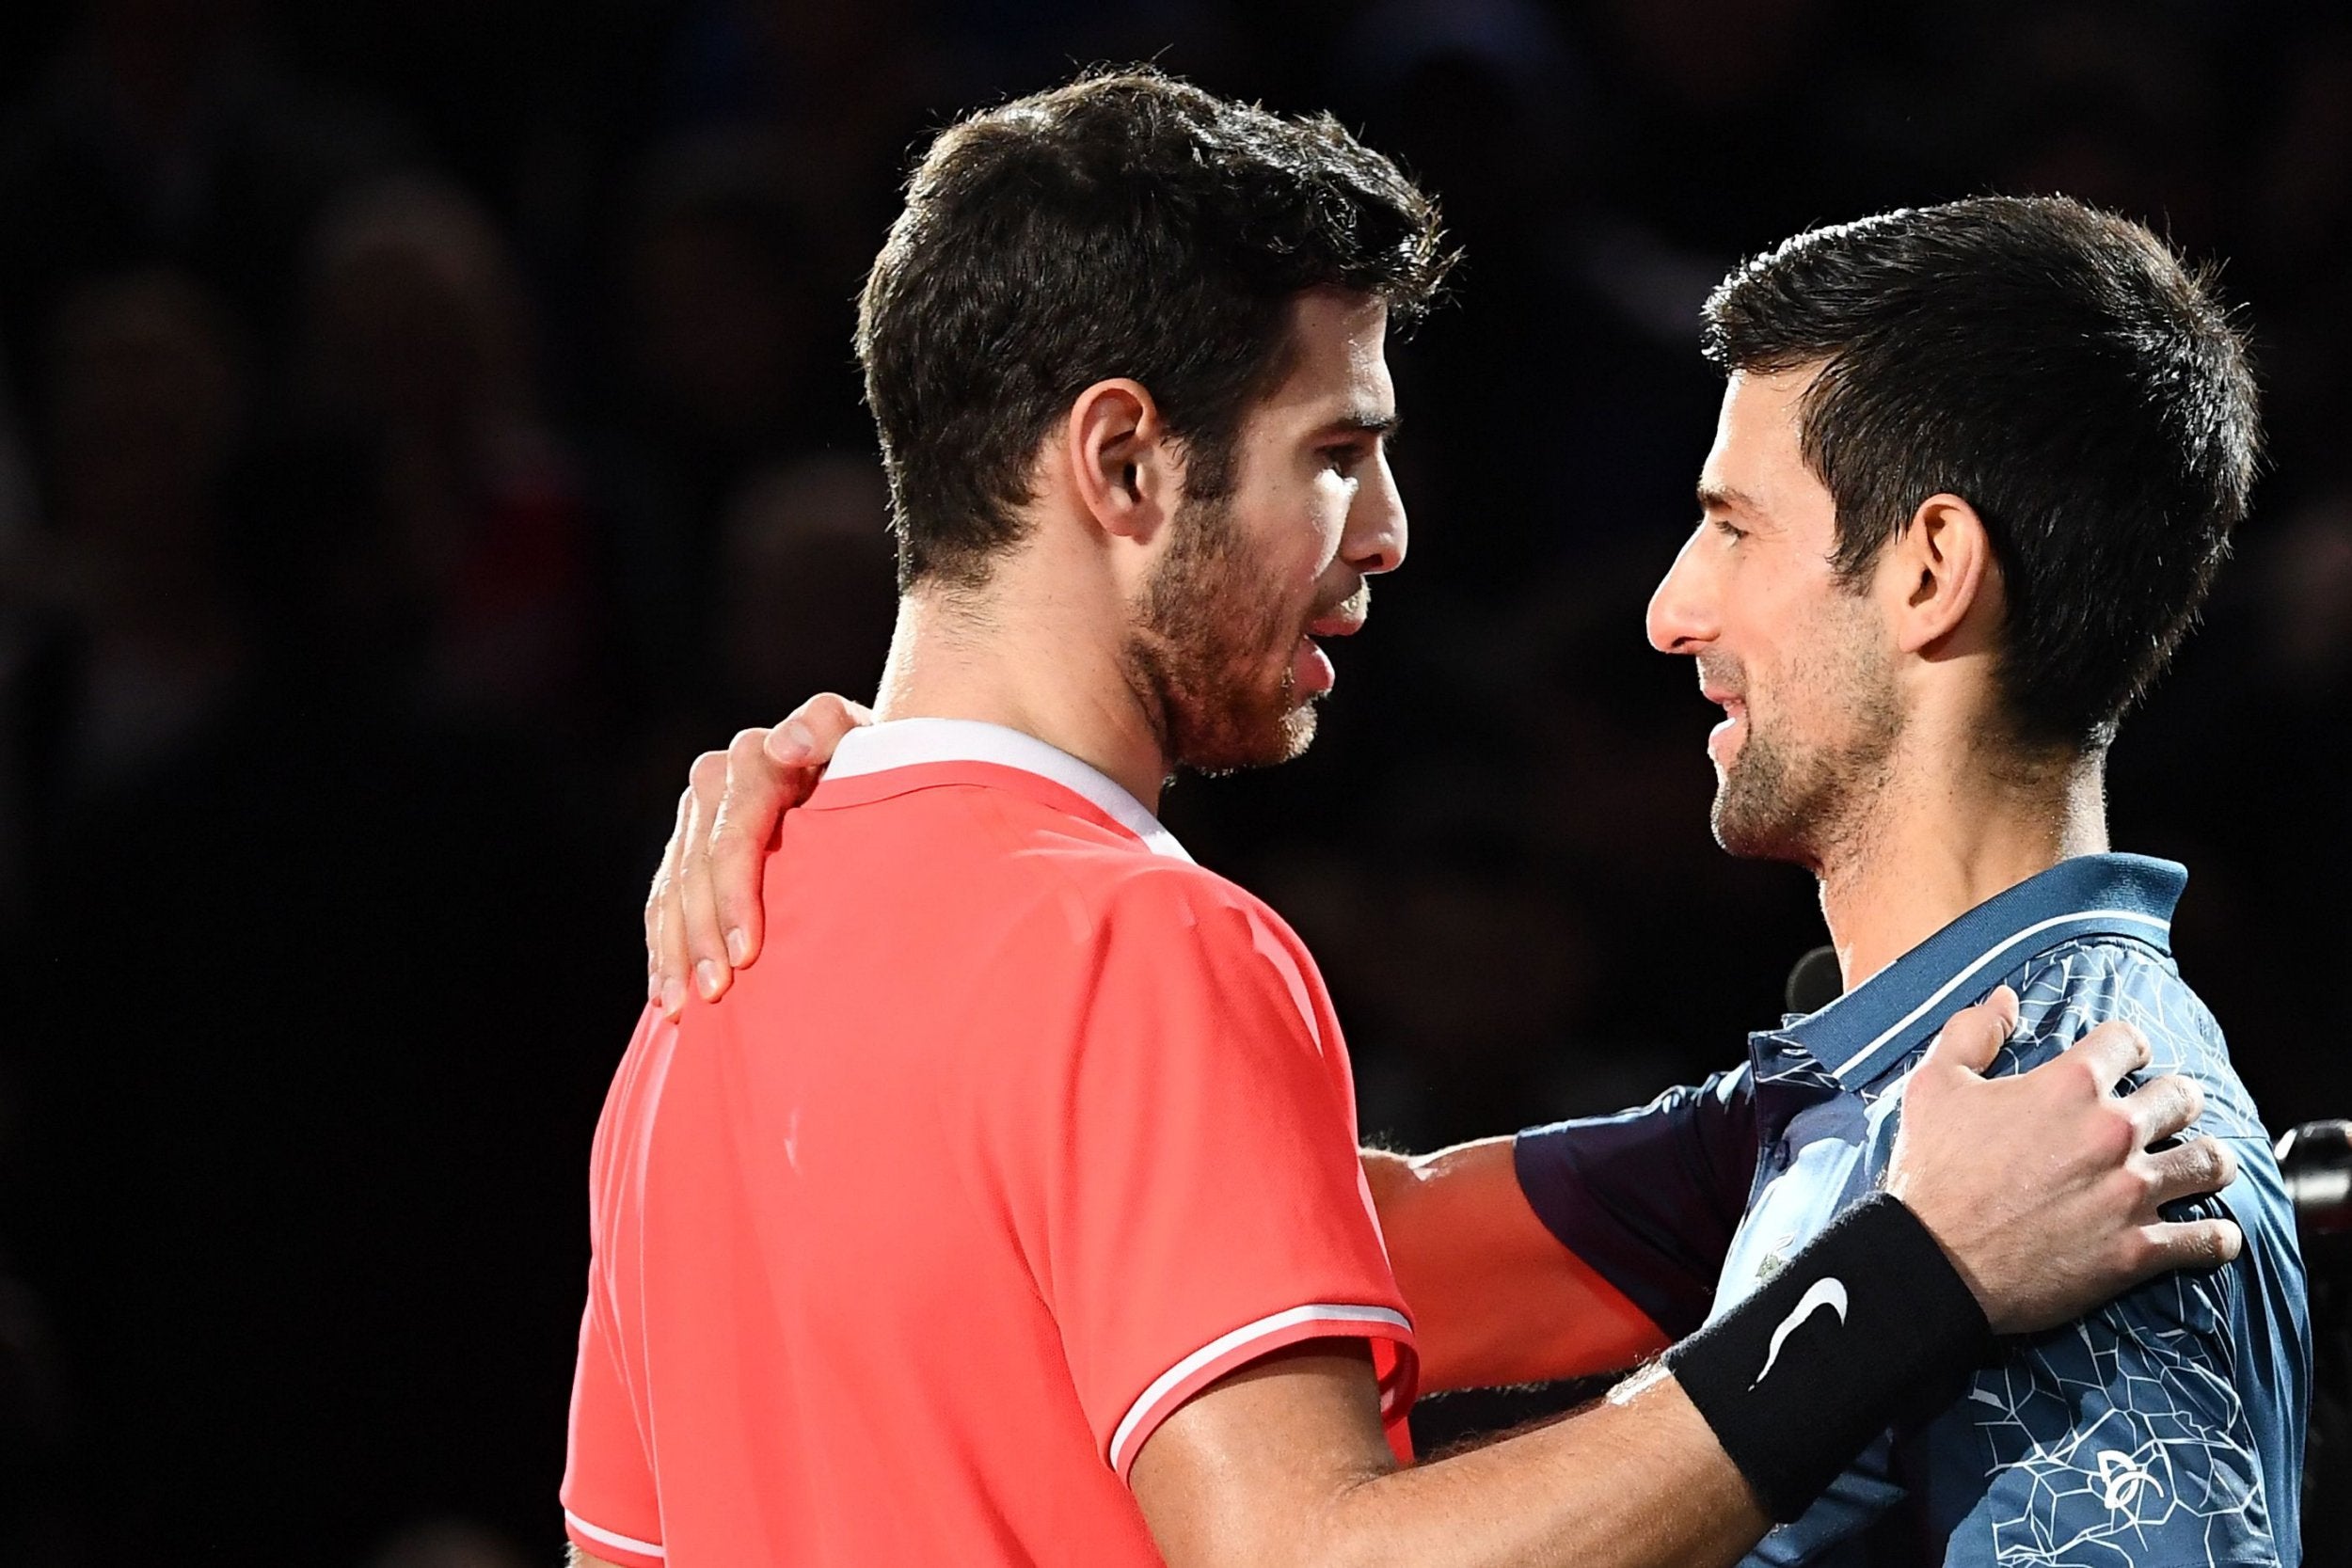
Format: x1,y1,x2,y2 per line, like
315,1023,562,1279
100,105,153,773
875,571,1169,814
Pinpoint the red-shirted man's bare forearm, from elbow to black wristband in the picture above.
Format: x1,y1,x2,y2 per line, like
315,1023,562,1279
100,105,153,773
1306,1373,1772,1568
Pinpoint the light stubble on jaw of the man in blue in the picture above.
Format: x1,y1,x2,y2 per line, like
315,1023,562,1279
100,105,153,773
1710,640,1903,872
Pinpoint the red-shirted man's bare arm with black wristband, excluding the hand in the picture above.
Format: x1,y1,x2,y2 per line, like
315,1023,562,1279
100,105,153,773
1132,1199,1988,1568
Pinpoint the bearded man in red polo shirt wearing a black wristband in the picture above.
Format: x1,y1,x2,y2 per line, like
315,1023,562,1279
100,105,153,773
564,72,2237,1568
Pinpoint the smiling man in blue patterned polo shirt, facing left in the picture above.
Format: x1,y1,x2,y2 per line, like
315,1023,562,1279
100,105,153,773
649,198,2310,1568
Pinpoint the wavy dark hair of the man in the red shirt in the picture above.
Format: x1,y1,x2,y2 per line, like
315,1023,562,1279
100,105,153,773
856,68,1452,585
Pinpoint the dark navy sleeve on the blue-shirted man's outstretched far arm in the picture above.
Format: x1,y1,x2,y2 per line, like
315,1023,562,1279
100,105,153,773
1513,1065,1757,1340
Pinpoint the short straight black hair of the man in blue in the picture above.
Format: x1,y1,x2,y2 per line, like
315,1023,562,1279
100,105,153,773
1706,198,2261,754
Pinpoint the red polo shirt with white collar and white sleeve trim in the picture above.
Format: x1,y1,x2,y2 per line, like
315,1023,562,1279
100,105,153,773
563,720,1414,1568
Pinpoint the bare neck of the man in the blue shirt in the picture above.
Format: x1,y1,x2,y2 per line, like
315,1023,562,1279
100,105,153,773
1816,748,2107,990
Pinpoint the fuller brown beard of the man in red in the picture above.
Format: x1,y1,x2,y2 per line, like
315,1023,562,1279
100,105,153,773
1127,500,1315,773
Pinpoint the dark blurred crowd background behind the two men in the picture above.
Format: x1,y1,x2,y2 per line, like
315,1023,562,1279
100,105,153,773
0,0,2352,1568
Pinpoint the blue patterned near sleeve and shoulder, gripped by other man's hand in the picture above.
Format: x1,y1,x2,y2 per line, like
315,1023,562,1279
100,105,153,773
1913,945,2310,1568
